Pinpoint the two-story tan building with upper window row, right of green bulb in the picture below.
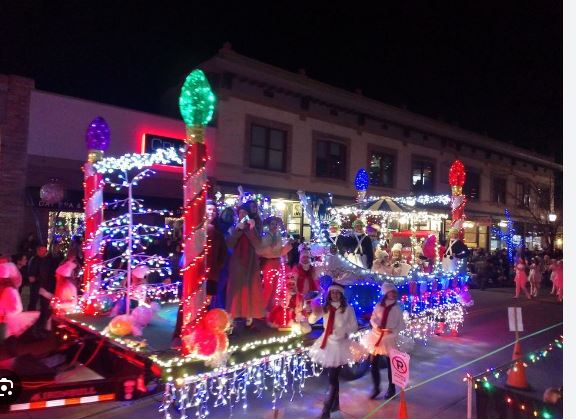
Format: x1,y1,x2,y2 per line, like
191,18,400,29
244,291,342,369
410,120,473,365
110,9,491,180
200,46,562,249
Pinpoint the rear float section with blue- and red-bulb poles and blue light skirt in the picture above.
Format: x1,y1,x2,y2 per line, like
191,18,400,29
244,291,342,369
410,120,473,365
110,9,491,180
299,161,473,342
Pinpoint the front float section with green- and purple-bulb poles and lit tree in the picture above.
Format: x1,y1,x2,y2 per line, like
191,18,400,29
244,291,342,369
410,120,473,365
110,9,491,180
14,70,321,418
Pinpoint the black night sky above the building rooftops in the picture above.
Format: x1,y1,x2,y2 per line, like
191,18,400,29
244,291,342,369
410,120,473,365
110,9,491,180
0,0,562,161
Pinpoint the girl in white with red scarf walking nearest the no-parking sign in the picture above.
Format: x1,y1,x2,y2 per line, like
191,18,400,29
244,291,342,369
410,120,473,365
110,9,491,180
362,283,406,399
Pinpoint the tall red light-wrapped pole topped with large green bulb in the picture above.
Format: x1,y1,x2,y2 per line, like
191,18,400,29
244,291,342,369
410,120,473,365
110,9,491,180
180,70,216,336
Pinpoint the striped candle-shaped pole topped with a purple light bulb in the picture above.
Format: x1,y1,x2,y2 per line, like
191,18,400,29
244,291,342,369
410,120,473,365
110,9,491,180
82,117,110,298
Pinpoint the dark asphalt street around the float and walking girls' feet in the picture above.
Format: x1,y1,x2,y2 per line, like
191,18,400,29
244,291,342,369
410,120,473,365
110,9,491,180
2,288,563,419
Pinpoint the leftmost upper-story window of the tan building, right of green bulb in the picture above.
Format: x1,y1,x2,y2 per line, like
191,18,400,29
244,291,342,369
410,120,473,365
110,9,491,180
250,124,286,172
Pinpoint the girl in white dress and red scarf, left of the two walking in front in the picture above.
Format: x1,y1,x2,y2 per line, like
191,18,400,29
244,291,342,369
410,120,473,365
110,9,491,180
308,283,366,419
